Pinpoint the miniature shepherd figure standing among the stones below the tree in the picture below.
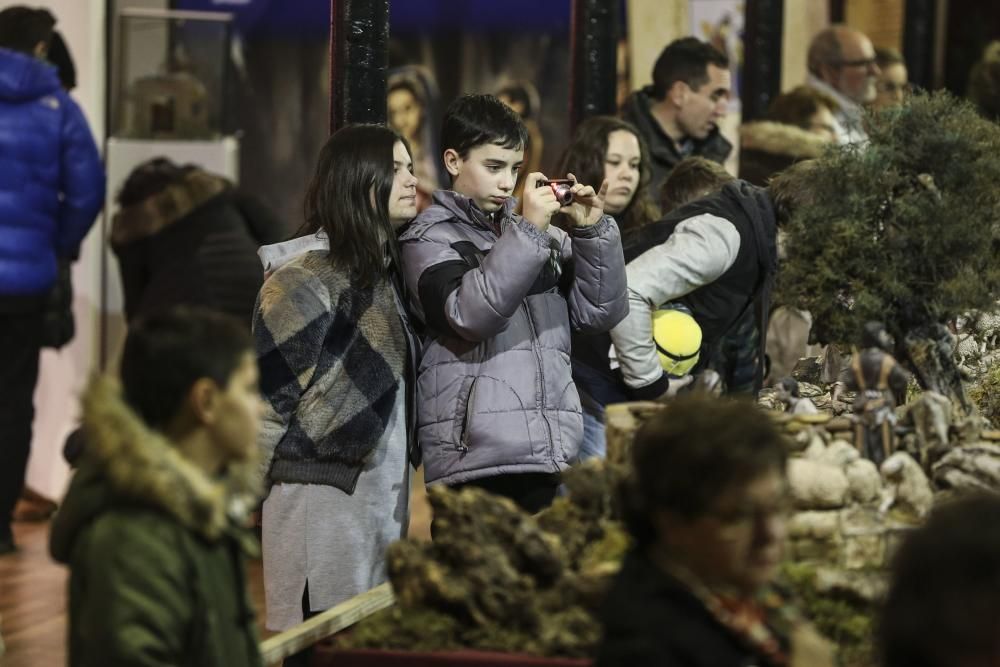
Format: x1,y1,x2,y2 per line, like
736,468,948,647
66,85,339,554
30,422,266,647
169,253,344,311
842,322,910,465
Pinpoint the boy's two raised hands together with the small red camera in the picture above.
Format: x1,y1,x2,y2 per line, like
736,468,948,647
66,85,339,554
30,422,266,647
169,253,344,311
523,172,608,232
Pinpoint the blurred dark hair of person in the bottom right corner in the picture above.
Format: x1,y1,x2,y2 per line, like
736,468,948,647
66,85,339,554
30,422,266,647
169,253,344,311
876,494,1000,667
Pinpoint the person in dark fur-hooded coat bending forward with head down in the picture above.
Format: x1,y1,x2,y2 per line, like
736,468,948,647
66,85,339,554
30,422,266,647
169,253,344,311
111,158,285,328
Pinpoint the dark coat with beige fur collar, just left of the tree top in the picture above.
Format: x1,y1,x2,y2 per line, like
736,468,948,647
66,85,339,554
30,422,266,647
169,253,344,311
740,121,830,187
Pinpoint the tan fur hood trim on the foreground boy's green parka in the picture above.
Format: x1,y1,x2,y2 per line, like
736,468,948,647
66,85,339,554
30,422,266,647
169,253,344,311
83,377,259,540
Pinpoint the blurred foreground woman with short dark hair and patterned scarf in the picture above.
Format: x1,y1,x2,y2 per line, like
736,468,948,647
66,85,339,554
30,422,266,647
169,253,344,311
596,395,833,667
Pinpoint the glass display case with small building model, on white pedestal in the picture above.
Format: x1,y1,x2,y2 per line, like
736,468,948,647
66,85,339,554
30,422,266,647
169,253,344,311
111,9,231,141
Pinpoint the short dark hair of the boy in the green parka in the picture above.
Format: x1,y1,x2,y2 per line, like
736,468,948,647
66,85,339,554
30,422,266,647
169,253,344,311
121,306,253,430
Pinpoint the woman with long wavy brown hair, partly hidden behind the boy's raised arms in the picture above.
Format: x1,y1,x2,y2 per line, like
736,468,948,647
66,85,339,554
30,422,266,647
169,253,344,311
557,116,660,461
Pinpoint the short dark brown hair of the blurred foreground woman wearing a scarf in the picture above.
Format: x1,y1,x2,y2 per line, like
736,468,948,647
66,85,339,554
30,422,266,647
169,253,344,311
622,394,787,547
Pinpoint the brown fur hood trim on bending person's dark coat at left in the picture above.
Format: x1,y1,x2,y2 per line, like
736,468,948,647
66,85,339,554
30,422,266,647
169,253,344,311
111,169,232,246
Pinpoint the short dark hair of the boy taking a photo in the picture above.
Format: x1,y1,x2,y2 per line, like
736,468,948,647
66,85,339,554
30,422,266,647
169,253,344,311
441,95,528,160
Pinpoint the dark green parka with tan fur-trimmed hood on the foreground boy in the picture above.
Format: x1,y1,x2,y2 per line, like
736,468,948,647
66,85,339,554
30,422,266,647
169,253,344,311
50,380,262,667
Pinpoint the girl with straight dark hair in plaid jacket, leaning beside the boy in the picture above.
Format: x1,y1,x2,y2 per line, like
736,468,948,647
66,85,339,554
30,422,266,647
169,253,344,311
254,125,417,665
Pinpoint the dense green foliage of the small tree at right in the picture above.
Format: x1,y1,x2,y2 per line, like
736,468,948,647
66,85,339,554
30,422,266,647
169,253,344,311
778,93,1000,344
